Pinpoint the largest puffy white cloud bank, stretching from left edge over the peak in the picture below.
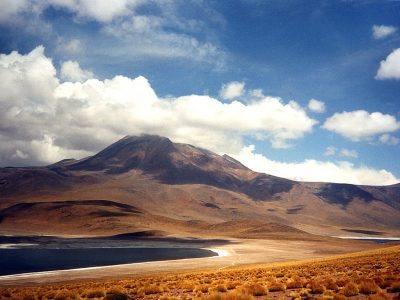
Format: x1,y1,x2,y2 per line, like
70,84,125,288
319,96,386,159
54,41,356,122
0,46,317,165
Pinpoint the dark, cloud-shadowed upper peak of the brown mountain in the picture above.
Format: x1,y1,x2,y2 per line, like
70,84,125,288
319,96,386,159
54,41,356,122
67,135,294,200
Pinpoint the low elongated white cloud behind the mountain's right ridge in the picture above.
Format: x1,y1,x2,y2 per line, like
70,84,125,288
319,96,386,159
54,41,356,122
231,145,400,185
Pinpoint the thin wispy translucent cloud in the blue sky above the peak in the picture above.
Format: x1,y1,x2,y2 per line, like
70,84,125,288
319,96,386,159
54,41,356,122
103,15,226,65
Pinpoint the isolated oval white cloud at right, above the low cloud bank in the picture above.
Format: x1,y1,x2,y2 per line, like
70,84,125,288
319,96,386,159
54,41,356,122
322,110,400,141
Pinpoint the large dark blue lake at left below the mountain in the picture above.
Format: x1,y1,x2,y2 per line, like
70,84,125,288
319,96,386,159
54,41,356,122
0,248,216,275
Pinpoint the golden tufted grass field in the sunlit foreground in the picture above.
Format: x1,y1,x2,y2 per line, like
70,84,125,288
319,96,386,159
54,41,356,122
0,246,400,300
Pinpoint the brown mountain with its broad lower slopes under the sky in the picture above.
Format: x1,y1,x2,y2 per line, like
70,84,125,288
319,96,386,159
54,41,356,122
0,135,400,237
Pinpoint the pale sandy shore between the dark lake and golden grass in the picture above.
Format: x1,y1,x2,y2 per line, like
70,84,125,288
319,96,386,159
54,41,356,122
0,238,390,286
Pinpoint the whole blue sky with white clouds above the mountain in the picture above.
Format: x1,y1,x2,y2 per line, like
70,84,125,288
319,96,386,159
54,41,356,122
0,0,400,185
